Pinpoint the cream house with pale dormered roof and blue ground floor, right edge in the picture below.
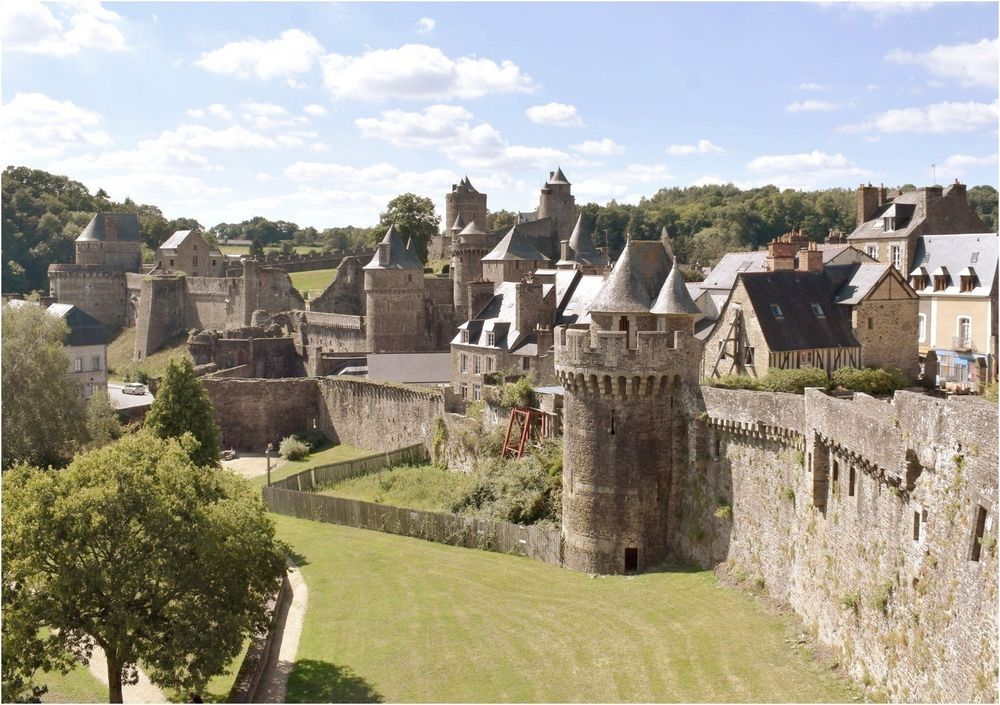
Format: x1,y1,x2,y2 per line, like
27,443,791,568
909,233,998,386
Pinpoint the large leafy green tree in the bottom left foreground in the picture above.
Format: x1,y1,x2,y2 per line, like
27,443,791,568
2,431,284,703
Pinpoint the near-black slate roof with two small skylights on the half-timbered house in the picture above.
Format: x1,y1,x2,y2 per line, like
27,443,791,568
739,271,861,352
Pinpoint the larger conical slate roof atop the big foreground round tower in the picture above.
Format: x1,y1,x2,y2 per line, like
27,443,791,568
590,240,670,313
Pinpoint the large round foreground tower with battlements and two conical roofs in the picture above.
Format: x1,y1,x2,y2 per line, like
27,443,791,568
555,241,702,573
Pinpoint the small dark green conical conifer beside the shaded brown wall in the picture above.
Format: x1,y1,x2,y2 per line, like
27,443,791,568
145,358,219,465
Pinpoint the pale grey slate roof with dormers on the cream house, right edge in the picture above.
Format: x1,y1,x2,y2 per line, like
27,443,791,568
913,233,998,296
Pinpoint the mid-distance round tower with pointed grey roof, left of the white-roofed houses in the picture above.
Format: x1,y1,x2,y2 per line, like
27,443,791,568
364,225,427,353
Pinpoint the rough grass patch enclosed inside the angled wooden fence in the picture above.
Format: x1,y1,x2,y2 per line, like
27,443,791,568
319,465,475,512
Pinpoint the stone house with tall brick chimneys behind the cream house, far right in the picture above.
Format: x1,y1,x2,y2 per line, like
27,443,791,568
847,181,989,274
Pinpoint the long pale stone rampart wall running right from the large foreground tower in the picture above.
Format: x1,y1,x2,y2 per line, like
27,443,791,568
672,388,997,702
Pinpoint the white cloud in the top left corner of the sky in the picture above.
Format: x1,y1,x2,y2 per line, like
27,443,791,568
0,0,127,56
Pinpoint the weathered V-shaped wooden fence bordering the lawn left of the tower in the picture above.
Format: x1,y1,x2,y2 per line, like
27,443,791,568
262,445,563,565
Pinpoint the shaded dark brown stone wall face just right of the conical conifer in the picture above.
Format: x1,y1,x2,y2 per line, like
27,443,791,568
201,375,329,452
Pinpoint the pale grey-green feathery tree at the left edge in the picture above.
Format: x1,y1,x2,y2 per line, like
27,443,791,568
0,305,86,469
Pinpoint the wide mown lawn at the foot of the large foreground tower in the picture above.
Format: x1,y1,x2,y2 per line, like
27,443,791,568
274,516,855,702
